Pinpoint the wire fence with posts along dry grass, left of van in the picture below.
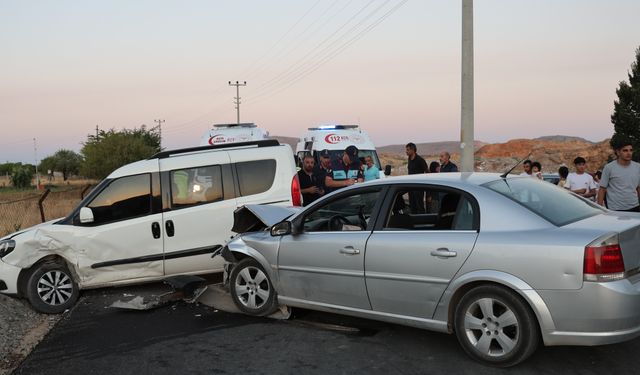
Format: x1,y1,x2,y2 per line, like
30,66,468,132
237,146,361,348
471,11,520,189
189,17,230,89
0,185,91,236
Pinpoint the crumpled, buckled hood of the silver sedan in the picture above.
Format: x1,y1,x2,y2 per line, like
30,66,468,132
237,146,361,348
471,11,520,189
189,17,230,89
231,204,301,233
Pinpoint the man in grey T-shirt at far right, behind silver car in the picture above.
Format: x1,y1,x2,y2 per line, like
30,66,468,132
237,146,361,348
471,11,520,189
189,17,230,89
598,141,640,212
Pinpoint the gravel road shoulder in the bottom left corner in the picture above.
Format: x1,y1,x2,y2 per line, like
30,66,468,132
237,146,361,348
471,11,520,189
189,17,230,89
0,294,63,375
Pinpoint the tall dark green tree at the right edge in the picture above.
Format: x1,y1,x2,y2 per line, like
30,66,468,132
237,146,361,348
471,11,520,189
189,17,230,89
611,47,640,161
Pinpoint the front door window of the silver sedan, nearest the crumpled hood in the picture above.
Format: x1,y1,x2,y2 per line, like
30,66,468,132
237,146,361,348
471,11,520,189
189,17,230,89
304,190,381,232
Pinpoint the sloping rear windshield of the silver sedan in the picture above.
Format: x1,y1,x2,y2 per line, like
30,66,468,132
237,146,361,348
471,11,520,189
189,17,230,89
483,177,604,226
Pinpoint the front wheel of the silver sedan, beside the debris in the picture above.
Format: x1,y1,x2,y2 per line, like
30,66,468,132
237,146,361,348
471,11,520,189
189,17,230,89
229,258,278,316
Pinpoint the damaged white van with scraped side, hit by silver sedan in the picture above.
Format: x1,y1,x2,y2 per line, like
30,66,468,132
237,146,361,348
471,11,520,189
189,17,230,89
0,140,301,313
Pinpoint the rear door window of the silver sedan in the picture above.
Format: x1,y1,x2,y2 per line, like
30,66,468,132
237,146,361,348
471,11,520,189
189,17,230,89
383,187,475,231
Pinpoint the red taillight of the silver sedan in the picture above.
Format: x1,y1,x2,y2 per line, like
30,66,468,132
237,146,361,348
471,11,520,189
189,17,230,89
583,234,625,281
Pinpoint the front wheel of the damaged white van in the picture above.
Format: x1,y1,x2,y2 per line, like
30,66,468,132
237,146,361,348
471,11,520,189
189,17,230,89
25,261,79,314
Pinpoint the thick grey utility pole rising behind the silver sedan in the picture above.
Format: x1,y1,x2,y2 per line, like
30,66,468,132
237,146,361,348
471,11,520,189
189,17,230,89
460,0,475,172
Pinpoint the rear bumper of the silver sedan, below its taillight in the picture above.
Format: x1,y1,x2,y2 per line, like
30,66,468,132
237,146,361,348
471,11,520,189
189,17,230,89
538,277,640,346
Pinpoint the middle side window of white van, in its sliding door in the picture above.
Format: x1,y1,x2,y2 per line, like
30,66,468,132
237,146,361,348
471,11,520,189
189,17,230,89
170,165,224,208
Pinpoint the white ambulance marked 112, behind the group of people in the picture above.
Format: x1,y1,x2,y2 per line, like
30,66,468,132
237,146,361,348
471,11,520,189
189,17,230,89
296,125,391,178
